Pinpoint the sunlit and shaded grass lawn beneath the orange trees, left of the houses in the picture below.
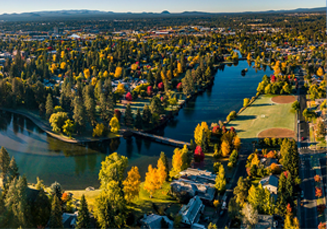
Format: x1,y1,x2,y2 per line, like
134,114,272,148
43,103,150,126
129,182,180,218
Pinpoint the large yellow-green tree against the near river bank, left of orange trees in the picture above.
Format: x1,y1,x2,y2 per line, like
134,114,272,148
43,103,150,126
99,153,128,188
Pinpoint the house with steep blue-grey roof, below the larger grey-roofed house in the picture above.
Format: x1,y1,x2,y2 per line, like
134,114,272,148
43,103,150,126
179,196,204,226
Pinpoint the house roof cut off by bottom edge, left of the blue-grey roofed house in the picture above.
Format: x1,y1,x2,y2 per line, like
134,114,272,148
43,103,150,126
141,214,174,229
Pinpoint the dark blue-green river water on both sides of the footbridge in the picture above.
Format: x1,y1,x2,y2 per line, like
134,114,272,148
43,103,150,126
0,61,272,190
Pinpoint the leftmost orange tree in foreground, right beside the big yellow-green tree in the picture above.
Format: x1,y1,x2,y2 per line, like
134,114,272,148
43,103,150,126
123,166,141,202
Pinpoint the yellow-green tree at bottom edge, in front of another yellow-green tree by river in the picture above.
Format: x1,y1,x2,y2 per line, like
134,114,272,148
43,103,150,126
94,180,127,229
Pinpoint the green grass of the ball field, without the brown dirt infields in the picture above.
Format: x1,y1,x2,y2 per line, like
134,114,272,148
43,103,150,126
228,95,295,138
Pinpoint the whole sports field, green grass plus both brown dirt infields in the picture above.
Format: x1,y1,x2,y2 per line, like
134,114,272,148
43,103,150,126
228,95,295,139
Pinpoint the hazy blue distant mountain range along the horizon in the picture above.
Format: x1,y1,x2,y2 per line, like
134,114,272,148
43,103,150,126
0,7,326,21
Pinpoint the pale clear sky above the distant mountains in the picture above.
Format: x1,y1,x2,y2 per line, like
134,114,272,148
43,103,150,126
0,0,326,14
